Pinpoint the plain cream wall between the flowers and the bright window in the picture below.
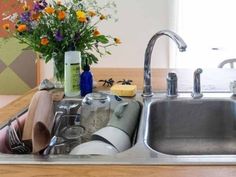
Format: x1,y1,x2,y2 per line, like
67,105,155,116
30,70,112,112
41,0,173,78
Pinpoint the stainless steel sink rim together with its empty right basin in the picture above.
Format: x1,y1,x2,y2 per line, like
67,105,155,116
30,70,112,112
0,92,236,165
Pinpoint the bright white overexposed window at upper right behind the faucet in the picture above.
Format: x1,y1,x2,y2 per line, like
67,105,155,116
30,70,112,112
170,0,236,68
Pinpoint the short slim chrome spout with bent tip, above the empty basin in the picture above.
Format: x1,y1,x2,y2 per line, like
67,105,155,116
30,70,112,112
192,68,203,98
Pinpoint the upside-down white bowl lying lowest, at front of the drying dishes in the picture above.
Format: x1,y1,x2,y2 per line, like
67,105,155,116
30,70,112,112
70,140,118,155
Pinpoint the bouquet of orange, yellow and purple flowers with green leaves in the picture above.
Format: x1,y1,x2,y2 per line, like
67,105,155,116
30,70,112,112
3,0,121,80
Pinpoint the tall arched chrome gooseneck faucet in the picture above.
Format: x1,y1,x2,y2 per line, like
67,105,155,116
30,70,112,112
143,30,187,97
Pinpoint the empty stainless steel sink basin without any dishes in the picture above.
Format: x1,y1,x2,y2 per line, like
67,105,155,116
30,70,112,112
146,98,236,155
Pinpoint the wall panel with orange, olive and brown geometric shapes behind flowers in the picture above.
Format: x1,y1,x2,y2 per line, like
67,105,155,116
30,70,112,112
0,0,36,95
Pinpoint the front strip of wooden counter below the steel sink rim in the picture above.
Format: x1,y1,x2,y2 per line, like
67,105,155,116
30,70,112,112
0,165,236,177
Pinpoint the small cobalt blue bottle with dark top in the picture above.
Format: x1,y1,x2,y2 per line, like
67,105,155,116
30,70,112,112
80,63,93,96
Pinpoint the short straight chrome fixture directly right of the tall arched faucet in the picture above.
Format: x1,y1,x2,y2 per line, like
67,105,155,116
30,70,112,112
166,72,177,98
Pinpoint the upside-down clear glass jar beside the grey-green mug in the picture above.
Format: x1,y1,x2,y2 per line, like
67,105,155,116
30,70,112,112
80,92,110,142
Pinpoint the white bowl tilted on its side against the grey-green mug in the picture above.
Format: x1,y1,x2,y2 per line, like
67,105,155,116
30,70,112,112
92,126,131,152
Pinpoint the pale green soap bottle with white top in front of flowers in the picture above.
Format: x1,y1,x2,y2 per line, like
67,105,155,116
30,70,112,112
64,51,81,97
